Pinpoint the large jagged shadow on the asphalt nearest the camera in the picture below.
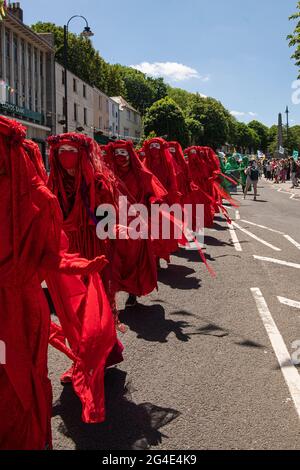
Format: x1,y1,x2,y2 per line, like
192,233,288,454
53,369,180,450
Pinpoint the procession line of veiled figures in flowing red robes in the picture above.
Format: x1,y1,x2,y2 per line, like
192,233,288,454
0,116,238,450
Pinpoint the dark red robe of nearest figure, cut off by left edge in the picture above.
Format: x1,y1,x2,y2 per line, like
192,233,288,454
0,116,52,450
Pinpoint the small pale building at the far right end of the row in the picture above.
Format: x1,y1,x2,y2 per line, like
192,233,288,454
112,96,142,142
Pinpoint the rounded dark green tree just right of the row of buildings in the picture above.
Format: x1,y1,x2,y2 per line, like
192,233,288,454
144,97,189,146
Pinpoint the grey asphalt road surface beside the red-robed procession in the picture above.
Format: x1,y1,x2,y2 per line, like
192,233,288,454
50,181,300,450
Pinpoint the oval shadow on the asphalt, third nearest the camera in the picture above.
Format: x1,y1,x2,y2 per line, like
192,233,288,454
158,264,201,290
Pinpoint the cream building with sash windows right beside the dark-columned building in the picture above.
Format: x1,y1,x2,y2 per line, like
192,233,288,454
55,62,94,137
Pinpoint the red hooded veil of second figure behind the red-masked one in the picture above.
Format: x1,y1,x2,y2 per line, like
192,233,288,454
144,138,181,205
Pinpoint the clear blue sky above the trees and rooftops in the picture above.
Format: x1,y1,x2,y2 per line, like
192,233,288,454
21,0,300,125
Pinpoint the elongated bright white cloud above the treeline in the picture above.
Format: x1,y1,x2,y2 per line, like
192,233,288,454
130,62,210,82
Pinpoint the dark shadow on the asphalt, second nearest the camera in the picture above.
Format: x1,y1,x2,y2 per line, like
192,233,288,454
120,304,190,343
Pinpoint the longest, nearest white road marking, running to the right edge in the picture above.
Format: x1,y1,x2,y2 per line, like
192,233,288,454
251,288,300,418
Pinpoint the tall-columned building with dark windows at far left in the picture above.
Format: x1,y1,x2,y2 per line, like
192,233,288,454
0,3,55,156
